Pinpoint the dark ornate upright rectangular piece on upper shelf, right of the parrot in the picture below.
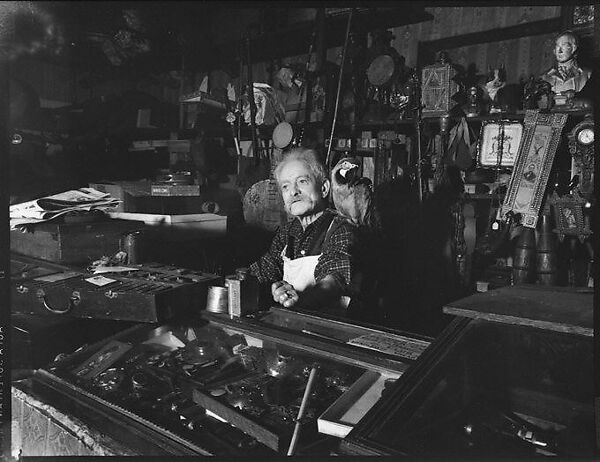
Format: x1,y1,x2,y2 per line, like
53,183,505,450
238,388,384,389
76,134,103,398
421,63,458,117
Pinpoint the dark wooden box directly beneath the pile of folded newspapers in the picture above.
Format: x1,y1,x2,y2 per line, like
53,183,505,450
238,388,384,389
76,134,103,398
10,219,143,265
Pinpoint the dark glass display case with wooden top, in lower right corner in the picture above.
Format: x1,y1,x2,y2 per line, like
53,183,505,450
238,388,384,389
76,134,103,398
341,286,595,458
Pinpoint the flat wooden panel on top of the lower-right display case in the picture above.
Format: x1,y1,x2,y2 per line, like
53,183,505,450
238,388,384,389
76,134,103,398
444,285,594,336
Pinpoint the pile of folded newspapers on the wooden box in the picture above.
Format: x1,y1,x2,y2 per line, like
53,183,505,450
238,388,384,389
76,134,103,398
9,188,121,229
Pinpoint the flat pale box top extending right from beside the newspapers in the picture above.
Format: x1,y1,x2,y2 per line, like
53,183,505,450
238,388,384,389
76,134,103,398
109,212,227,234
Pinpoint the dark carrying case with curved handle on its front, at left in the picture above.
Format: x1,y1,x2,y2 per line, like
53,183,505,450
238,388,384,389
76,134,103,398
11,264,222,322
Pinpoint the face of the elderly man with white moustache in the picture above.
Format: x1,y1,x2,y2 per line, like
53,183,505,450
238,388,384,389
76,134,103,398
279,160,329,217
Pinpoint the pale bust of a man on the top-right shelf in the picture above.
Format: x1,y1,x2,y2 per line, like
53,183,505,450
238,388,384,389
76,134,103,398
541,30,592,106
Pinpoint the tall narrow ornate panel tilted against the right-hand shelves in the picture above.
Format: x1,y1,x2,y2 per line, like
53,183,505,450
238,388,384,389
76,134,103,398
498,110,567,228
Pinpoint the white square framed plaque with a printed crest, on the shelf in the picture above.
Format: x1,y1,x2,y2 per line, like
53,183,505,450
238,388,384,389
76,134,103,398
477,120,523,167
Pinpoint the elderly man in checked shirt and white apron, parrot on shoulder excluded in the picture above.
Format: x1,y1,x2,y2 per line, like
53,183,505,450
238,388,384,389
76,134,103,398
250,148,354,314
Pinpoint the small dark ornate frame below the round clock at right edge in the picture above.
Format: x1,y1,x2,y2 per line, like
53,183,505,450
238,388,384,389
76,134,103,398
550,193,592,242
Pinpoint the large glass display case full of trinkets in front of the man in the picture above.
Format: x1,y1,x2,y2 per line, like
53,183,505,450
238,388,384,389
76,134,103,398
18,308,430,456
